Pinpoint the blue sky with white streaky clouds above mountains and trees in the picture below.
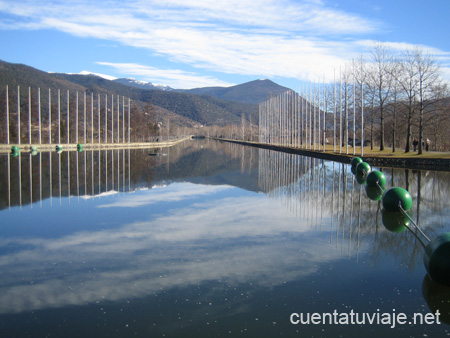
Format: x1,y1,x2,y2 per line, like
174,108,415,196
0,0,450,90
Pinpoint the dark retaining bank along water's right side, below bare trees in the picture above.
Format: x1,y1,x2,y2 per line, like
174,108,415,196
211,137,450,171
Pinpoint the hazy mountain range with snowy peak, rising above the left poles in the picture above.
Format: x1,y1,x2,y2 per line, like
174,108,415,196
0,61,289,126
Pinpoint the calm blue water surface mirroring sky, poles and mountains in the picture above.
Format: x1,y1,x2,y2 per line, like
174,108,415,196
0,141,450,337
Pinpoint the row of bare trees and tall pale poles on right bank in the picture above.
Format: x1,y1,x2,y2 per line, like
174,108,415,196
212,43,450,154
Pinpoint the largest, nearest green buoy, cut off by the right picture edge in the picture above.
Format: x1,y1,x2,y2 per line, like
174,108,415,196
423,232,450,286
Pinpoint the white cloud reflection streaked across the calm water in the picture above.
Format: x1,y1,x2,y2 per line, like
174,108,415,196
0,183,352,313
